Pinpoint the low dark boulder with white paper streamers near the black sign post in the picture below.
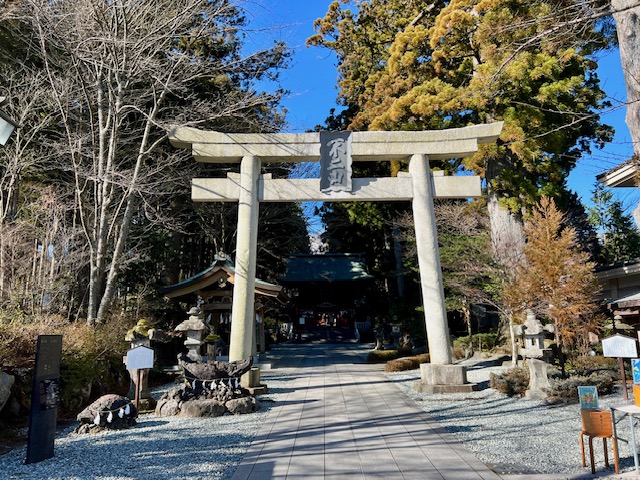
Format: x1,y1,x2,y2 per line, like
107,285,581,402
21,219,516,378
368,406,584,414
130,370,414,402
76,394,138,433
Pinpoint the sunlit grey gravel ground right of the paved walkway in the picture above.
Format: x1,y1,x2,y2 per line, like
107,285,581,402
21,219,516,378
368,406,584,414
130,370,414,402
386,360,640,474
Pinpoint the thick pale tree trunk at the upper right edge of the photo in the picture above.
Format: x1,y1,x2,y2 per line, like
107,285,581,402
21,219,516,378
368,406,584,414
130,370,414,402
611,0,640,158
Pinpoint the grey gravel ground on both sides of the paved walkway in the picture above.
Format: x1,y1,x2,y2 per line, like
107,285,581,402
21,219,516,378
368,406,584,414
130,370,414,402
0,346,633,480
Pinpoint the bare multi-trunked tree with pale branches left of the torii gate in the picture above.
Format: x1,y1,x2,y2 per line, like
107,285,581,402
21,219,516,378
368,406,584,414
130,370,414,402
2,0,284,322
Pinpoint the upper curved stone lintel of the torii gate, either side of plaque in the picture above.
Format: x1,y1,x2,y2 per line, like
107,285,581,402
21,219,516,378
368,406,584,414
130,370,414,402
169,122,503,163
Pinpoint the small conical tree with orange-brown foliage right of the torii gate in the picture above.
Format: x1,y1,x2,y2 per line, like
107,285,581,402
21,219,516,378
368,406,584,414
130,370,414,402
503,197,600,358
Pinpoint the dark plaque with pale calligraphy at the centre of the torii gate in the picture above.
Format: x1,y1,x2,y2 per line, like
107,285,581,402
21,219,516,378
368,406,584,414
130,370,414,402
320,132,352,193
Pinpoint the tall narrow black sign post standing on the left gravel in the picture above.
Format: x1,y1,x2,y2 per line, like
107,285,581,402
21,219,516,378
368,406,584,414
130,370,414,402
25,335,62,463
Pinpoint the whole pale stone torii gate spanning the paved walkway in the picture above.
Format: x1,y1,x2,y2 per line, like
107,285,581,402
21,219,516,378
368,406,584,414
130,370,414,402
169,122,502,372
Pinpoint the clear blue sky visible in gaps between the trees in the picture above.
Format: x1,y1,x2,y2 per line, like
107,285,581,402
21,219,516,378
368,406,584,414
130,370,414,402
244,0,640,211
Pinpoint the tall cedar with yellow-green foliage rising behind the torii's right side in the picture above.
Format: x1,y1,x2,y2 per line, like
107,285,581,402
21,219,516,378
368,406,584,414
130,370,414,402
308,0,611,272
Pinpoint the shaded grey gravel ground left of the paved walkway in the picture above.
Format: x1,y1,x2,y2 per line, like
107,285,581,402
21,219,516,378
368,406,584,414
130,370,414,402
0,375,284,480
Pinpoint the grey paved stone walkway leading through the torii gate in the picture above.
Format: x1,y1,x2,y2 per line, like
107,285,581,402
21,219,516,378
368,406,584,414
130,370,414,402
233,344,500,480
